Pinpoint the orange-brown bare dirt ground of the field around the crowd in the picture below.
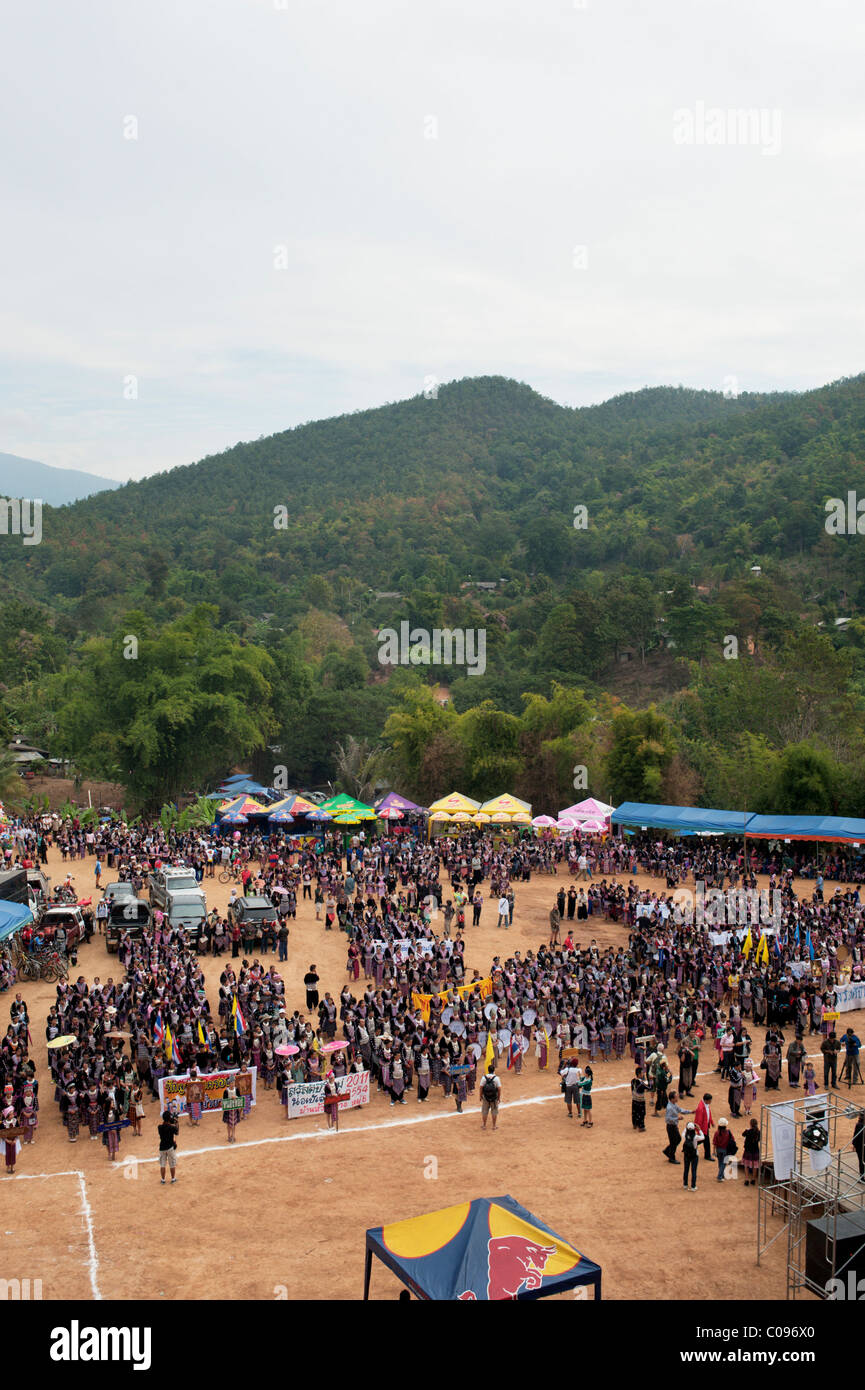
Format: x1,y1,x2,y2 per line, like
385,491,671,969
8,851,865,1300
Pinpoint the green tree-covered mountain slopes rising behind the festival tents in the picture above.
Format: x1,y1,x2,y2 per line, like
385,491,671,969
0,377,865,810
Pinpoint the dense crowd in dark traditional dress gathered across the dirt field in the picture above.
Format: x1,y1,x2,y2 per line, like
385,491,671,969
0,821,865,1182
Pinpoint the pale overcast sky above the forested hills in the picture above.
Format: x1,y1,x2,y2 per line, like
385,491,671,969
0,0,865,480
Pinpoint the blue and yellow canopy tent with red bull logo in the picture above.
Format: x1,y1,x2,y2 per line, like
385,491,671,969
363,1197,601,1302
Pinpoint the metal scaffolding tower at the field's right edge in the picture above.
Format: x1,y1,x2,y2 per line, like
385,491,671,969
757,1091,865,1298
